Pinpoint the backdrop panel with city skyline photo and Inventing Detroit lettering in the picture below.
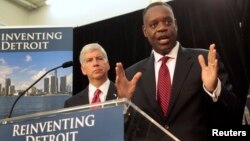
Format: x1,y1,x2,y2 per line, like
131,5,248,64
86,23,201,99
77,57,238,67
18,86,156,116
0,27,73,96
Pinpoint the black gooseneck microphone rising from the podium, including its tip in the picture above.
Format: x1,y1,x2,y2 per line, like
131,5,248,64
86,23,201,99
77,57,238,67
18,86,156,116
7,61,73,118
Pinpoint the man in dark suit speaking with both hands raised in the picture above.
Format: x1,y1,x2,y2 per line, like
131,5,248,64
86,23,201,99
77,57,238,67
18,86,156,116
116,2,239,141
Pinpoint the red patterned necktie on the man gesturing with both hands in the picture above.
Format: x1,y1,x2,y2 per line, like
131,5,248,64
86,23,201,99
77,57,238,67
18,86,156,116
157,56,171,117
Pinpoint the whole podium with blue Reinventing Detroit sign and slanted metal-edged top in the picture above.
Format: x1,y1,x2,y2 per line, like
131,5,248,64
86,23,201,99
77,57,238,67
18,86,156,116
0,99,179,141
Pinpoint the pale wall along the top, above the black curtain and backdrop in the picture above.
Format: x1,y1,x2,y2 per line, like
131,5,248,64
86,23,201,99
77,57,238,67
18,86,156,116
0,0,169,26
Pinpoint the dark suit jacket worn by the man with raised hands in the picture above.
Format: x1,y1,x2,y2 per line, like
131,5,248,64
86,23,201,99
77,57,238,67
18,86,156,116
126,46,239,141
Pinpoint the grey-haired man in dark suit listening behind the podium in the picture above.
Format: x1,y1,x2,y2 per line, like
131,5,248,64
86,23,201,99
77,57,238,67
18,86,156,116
64,43,116,107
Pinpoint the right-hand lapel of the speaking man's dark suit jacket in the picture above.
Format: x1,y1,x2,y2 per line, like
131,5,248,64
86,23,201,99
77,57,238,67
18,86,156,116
168,46,194,117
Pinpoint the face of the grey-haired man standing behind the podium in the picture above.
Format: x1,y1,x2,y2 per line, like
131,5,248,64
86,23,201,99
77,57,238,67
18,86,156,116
81,50,110,81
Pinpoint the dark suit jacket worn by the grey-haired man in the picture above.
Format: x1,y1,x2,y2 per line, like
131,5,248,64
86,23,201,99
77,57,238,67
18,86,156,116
64,81,117,107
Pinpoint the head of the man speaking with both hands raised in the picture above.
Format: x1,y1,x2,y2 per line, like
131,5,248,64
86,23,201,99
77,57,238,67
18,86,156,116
143,5,177,55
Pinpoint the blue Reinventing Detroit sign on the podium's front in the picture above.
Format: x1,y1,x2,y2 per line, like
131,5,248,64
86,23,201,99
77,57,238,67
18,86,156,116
0,106,124,141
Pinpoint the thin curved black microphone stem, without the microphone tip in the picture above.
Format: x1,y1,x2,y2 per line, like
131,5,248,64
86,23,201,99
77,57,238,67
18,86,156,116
7,65,63,118
